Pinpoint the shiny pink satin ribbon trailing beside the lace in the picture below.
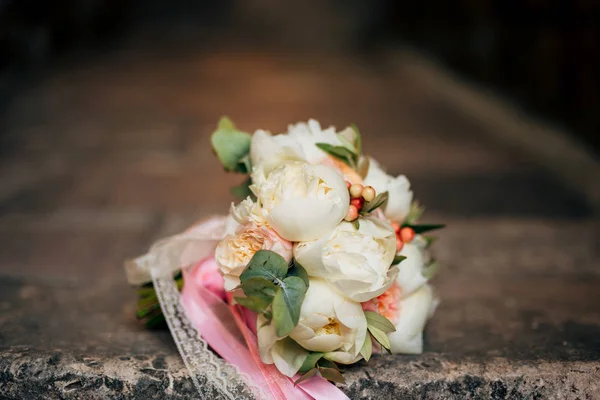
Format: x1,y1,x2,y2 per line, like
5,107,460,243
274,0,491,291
181,257,349,400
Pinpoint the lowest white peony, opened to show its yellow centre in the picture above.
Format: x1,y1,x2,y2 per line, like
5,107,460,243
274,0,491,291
290,278,367,364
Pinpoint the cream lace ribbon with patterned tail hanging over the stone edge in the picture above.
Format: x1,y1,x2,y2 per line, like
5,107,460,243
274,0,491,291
125,217,267,400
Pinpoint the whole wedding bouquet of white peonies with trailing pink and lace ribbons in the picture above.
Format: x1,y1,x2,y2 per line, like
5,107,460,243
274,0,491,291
126,118,443,399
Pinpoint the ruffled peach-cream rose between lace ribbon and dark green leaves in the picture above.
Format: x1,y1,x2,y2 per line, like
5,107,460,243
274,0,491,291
215,223,292,291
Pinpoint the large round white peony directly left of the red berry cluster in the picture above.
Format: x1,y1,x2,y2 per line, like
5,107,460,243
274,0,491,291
252,162,350,242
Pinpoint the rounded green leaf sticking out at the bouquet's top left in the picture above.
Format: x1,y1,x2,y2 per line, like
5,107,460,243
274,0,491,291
210,117,252,172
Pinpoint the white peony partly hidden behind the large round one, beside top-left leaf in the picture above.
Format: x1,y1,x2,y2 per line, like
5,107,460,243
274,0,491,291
250,129,305,172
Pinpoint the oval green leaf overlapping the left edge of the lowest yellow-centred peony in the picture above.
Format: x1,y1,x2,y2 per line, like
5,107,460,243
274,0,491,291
272,276,306,337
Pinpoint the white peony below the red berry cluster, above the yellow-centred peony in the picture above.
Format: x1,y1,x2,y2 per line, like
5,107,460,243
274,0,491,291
294,216,398,302
